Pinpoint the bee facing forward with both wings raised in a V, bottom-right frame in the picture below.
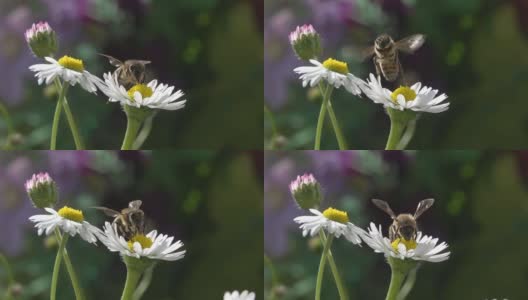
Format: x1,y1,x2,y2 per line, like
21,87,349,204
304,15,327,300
372,198,434,242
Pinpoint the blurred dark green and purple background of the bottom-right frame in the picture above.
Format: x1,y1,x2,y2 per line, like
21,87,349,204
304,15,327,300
264,151,528,300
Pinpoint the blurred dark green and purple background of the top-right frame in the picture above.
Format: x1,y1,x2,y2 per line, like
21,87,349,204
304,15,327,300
264,0,528,149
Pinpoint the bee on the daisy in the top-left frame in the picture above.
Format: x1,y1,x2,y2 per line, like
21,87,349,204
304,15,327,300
100,54,150,90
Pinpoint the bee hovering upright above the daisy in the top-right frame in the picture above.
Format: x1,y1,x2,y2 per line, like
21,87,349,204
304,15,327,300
363,33,425,82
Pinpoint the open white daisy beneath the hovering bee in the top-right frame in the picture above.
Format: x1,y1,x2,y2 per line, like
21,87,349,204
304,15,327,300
362,73,449,113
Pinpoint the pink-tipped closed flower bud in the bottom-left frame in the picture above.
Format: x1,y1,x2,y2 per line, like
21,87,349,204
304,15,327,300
25,173,58,208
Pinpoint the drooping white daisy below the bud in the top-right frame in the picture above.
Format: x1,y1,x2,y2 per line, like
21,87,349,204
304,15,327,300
293,58,365,95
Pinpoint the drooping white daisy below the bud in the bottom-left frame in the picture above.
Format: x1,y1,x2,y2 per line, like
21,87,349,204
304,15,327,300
29,206,101,244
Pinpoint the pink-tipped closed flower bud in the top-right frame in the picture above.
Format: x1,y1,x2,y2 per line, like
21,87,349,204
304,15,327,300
290,25,322,60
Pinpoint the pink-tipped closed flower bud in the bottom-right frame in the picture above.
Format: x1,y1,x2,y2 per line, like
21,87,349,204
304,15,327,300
290,174,322,209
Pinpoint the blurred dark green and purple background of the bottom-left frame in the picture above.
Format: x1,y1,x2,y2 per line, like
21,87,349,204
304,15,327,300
0,151,263,300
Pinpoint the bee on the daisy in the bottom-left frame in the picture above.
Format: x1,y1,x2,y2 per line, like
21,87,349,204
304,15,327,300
94,200,145,241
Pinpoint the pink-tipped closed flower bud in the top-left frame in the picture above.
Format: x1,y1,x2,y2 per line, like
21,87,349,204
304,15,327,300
25,22,58,58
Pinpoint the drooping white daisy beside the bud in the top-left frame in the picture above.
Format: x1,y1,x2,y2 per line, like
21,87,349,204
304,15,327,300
29,56,101,94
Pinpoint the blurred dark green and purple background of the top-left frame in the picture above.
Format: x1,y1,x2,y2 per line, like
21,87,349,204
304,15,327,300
0,0,263,149
